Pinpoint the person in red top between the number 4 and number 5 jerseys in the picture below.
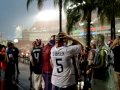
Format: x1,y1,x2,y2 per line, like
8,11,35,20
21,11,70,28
42,35,55,90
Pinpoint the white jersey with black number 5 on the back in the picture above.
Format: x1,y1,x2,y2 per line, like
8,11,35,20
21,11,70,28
51,45,80,88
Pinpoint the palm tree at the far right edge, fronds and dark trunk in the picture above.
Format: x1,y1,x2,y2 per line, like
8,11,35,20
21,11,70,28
98,0,120,40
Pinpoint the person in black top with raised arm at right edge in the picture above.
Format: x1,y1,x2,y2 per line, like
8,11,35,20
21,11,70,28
110,36,120,90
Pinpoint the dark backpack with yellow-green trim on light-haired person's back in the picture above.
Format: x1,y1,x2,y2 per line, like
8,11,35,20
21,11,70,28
93,46,110,81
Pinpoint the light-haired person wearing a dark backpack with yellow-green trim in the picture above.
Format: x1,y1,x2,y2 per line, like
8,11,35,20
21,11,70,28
92,34,109,90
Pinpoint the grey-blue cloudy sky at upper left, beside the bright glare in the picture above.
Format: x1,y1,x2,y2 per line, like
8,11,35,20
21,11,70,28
0,0,54,39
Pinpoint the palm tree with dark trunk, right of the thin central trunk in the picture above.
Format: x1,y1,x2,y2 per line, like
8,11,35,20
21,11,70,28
64,0,97,47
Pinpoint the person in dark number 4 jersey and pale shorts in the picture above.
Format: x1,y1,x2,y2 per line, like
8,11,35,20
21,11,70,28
31,39,43,90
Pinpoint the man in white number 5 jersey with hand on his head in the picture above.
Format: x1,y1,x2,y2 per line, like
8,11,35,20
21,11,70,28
51,33,82,90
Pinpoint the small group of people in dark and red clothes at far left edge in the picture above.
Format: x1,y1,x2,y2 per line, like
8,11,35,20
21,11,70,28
0,42,20,90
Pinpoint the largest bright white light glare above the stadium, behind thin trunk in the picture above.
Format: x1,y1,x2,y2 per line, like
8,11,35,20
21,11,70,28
35,9,65,21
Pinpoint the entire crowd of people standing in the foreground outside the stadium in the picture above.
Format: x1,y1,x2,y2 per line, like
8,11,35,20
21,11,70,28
0,32,120,90
